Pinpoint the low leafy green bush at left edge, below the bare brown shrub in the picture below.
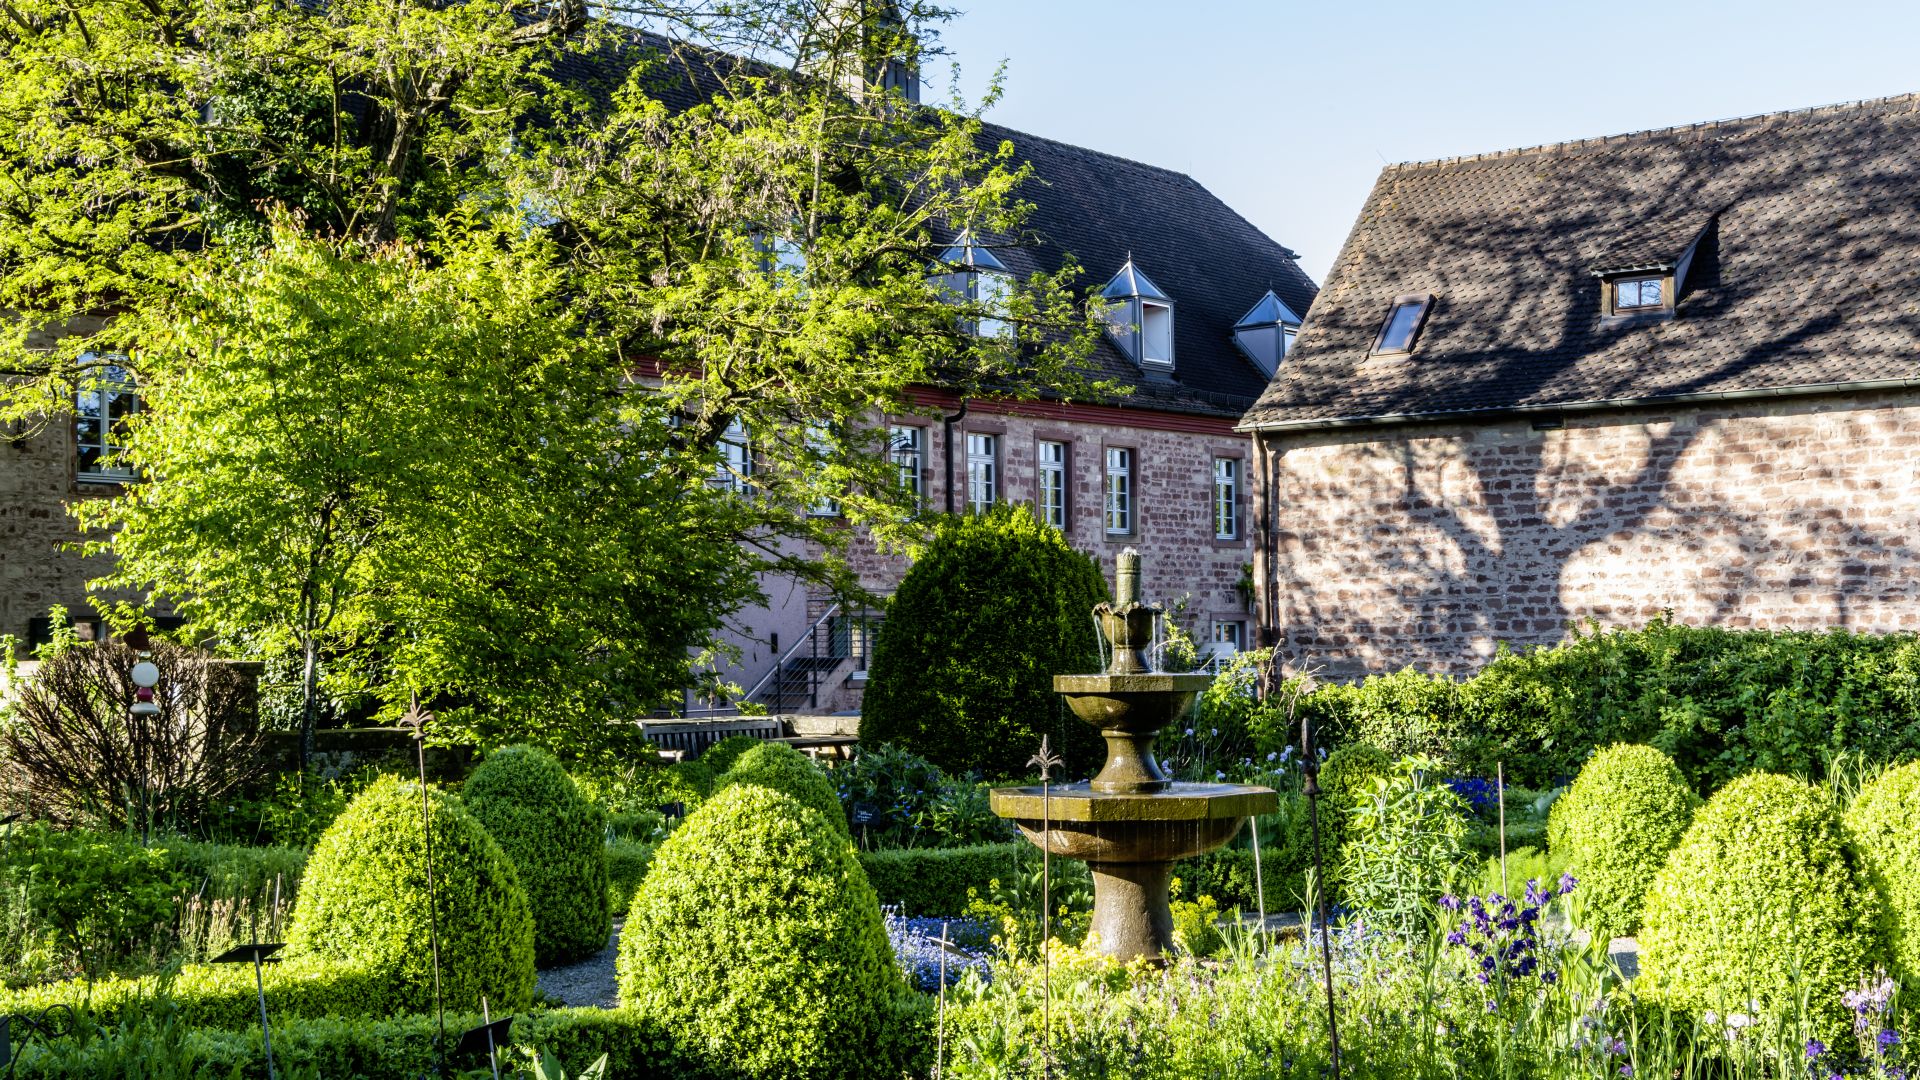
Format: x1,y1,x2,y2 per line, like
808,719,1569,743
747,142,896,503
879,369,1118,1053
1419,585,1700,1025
0,824,186,976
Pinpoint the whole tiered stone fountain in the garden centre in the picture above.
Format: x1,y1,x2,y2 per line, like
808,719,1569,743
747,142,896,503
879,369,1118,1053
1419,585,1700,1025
993,548,1279,961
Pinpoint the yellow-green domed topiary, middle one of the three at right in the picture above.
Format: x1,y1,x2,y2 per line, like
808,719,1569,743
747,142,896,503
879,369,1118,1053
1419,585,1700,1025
1636,773,1885,1042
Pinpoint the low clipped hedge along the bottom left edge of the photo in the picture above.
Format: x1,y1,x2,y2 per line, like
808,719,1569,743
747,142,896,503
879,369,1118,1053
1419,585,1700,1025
15,999,724,1080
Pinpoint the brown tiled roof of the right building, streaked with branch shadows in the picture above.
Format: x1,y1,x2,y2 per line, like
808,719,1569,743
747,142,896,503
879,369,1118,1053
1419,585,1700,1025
1242,94,1920,429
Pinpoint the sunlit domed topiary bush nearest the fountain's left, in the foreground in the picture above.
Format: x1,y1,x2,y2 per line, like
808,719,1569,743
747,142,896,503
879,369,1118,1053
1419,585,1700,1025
618,784,912,1080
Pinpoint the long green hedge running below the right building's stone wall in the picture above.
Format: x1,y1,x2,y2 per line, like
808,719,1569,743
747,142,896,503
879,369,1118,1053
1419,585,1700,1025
1251,619,1920,792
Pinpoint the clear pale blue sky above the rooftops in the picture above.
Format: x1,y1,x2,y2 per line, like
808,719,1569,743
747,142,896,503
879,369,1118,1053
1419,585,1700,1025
925,0,1920,281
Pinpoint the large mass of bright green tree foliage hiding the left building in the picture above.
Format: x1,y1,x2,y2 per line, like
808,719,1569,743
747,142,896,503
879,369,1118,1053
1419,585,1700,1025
0,0,1098,742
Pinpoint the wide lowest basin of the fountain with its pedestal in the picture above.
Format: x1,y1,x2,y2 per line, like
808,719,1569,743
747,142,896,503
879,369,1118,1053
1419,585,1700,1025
989,784,1281,963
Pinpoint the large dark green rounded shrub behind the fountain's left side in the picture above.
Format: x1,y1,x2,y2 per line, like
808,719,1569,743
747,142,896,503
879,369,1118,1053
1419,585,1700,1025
860,505,1108,776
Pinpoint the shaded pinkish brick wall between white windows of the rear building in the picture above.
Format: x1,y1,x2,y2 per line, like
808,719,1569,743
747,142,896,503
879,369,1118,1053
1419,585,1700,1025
812,390,1254,711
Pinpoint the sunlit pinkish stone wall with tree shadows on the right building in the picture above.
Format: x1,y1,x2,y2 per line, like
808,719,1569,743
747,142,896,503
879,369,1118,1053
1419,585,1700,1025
1258,392,1920,676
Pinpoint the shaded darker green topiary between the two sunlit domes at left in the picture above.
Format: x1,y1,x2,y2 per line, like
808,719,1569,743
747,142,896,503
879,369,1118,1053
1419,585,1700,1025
461,746,612,967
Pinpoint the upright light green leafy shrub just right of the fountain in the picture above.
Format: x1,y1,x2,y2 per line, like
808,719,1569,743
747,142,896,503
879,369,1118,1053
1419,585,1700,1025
1336,757,1467,934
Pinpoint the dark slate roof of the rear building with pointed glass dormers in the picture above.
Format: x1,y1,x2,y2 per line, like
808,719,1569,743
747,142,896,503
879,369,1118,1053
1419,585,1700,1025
557,35,1317,417
